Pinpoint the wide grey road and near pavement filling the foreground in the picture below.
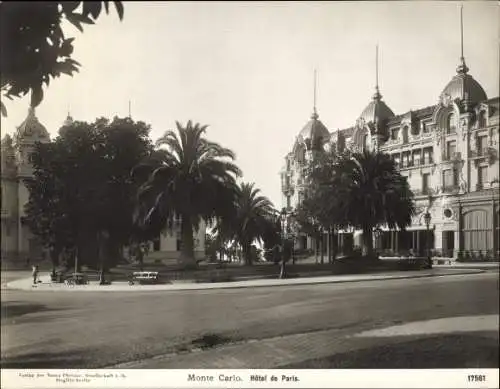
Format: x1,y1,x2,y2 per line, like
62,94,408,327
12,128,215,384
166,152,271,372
1,272,499,368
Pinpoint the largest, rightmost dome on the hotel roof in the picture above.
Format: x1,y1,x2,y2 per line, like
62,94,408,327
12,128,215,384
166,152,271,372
440,58,488,103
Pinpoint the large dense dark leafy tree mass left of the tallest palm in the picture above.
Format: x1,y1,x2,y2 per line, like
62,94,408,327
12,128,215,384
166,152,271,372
23,118,153,265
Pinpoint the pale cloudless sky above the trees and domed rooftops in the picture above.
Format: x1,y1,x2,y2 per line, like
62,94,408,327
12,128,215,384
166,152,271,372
1,1,500,208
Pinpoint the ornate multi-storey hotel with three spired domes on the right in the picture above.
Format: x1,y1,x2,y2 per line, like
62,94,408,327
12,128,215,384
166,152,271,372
281,56,500,258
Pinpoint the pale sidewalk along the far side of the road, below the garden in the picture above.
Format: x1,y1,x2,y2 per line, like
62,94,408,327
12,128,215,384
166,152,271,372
2,266,484,292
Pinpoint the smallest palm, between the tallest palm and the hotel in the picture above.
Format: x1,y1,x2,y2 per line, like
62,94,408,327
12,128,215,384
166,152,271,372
217,183,275,265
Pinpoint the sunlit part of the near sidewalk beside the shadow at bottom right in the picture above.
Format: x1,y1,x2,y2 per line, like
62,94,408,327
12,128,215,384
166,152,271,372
108,314,498,369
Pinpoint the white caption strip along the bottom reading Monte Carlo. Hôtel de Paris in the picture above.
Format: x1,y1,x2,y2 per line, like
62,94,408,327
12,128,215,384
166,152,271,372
1,368,499,389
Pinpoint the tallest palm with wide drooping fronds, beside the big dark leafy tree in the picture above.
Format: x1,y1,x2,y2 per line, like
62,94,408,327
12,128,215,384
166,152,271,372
136,121,241,268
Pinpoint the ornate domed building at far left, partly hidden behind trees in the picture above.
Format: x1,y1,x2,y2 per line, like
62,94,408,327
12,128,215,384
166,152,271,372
1,109,205,264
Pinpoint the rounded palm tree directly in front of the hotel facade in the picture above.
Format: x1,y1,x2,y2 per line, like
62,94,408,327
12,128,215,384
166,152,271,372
330,151,415,256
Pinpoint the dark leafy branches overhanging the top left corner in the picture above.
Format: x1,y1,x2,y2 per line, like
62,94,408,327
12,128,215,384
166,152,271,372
0,1,123,116
